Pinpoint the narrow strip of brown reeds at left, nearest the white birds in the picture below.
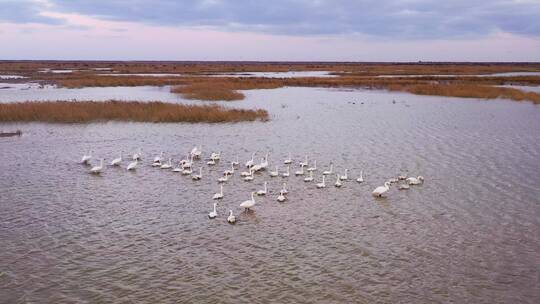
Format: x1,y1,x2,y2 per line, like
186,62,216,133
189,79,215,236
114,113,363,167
0,100,268,123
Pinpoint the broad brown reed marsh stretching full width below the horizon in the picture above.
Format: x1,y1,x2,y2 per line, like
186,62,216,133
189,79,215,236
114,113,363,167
0,61,540,103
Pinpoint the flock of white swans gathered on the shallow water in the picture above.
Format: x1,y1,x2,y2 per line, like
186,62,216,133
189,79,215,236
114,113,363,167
81,146,424,224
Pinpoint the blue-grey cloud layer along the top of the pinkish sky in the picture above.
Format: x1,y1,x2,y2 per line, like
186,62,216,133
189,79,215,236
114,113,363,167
0,0,540,39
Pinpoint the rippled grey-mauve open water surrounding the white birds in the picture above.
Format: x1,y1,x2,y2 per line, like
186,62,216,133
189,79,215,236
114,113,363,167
0,88,540,303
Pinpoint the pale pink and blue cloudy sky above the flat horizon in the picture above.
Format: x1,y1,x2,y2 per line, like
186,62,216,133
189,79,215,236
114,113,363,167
0,0,540,62
